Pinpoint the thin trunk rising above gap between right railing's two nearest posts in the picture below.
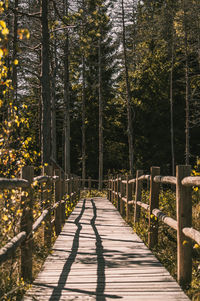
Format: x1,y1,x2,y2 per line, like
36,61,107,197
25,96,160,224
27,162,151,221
170,35,175,176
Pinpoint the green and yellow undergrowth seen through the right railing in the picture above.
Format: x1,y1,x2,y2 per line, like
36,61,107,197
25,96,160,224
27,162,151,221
132,190,200,301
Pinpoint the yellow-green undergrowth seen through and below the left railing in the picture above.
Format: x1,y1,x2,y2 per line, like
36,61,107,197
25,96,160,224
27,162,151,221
0,194,78,301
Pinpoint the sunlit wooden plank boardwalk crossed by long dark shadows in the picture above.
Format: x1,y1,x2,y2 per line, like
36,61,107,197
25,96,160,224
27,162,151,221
23,198,189,301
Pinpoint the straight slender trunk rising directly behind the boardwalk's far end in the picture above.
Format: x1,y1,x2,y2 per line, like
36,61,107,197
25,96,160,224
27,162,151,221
98,38,103,190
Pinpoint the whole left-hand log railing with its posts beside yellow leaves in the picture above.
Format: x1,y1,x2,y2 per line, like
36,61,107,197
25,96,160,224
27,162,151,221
0,166,79,281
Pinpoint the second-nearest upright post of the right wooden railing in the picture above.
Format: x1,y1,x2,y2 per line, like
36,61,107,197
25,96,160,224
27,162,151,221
148,167,160,249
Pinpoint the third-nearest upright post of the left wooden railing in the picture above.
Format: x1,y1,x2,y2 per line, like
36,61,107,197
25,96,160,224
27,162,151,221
55,169,62,236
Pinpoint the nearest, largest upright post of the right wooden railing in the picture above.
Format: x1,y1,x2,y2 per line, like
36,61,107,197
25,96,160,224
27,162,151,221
176,165,192,287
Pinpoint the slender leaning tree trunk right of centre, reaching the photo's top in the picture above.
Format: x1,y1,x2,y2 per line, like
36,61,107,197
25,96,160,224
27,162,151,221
121,0,134,175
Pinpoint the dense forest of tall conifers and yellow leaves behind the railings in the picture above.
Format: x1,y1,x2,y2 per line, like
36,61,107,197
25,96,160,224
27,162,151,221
0,0,200,178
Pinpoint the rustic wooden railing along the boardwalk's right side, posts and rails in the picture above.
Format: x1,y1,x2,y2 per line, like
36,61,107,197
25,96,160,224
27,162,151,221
108,165,200,287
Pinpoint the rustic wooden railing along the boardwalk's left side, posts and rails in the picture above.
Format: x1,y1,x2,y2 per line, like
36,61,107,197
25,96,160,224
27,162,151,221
0,166,80,282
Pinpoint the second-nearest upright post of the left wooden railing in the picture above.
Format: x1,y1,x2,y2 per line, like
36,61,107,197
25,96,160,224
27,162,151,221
43,165,53,248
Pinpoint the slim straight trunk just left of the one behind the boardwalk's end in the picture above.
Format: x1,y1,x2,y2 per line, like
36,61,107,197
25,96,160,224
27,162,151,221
82,55,86,187
